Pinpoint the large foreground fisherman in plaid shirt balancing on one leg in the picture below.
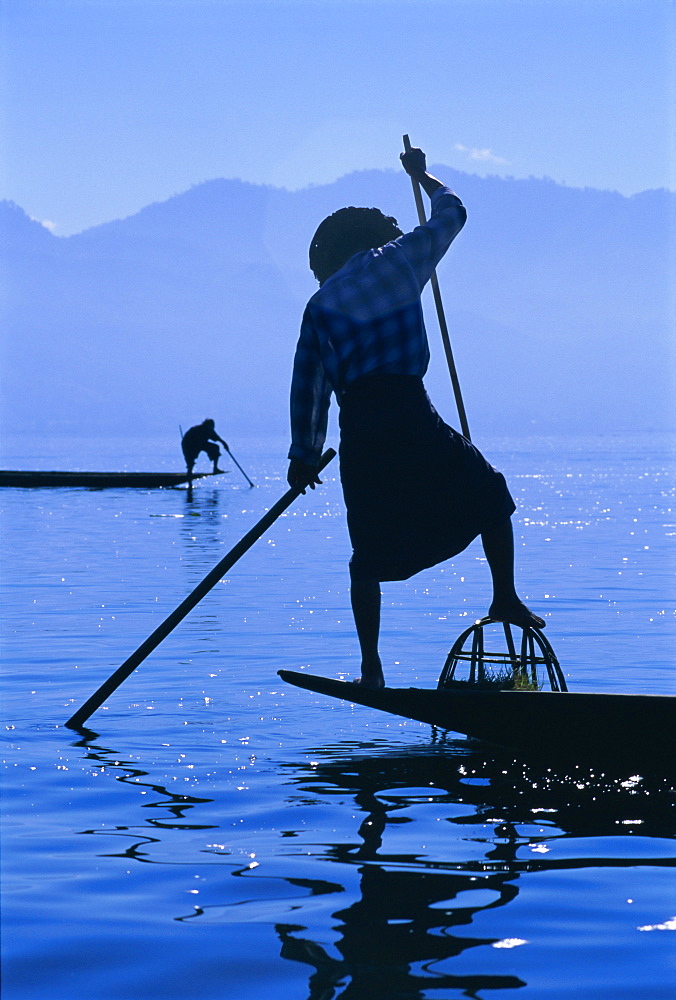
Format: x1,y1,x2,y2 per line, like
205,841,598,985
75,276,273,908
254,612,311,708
288,149,545,687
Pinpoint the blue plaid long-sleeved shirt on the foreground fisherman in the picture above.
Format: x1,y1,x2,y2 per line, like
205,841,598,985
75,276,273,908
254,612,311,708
289,187,467,465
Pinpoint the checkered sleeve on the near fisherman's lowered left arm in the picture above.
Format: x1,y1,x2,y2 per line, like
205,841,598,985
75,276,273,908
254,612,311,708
289,309,331,465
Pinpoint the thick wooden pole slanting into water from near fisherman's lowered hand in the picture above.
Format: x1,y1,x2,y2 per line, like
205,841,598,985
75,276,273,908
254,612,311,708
66,448,336,729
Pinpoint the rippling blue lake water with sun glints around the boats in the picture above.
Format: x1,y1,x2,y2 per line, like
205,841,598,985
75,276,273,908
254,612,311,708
0,436,676,1000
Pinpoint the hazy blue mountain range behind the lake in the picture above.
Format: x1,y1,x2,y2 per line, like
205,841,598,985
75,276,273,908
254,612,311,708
0,167,676,439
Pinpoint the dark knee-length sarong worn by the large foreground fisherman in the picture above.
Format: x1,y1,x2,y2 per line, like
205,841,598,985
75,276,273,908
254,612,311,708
340,375,515,580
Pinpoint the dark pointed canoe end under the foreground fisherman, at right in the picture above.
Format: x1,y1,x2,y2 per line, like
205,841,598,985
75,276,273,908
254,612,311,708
279,670,676,771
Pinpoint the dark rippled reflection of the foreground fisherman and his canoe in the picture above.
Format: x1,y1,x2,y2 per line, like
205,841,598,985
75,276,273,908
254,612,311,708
276,744,671,1000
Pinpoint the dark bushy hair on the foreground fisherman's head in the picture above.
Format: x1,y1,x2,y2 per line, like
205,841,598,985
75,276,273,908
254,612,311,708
310,208,403,285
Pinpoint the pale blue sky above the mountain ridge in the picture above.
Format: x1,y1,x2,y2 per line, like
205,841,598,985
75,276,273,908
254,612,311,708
0,0,674,235
